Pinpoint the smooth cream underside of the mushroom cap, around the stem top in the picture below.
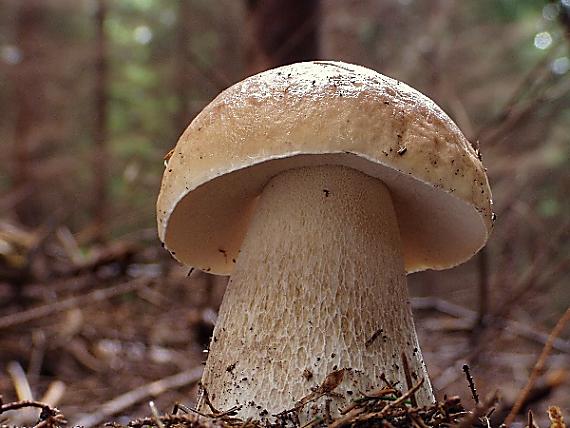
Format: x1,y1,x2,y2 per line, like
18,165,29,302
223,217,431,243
163,153,489,275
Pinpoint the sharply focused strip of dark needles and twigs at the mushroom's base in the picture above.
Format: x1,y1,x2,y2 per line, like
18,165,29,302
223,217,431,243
0,378,566,428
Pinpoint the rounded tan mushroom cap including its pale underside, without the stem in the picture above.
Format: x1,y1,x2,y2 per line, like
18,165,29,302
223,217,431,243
157,61,492,274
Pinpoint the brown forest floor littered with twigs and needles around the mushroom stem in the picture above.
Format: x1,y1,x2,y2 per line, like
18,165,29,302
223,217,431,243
0,226,570,428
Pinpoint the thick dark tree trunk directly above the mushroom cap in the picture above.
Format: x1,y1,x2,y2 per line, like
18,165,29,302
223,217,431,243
246,0,320,74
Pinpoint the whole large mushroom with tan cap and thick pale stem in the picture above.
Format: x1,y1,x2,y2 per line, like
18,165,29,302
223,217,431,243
157,61,492,420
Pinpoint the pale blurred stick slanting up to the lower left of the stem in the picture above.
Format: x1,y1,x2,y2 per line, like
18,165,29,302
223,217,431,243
71,367,203,428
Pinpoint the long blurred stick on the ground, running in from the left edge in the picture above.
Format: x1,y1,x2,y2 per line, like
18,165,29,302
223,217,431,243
0,278,152,330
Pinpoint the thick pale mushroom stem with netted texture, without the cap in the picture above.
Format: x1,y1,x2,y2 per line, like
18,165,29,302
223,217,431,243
202,165,434,420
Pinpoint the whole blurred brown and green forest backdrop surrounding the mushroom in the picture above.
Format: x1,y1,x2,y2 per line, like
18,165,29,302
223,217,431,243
0,0,570,426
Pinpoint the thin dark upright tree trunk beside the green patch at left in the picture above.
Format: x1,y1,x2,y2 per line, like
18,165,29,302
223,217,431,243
93,0,109,241
